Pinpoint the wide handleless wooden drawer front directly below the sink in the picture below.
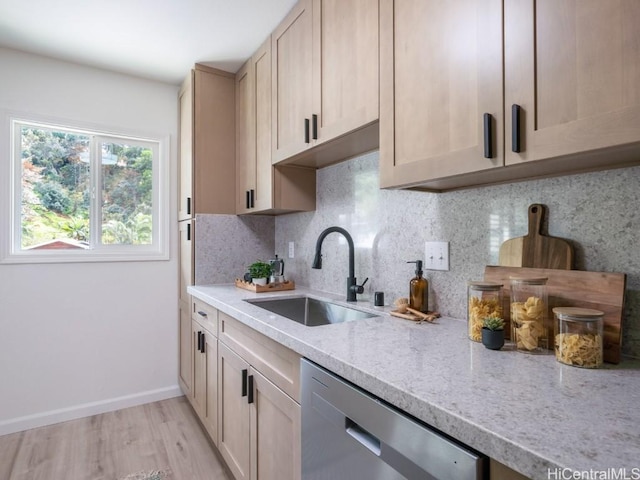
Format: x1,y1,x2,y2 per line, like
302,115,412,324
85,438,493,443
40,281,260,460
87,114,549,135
219,312,301,403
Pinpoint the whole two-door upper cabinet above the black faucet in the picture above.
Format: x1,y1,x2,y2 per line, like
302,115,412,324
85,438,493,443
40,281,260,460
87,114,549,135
272,0,379,167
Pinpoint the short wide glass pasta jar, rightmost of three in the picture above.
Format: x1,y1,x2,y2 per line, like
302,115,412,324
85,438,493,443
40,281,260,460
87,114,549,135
553,307,604,368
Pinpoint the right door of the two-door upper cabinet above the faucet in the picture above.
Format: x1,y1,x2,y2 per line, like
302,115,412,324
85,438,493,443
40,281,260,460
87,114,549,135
313,0,379,142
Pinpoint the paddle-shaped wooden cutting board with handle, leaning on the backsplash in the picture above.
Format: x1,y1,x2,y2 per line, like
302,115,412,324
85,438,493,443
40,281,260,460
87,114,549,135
498,203,573,270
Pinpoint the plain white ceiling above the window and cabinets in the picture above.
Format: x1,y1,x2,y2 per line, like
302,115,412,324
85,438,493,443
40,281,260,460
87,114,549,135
0,0,296,85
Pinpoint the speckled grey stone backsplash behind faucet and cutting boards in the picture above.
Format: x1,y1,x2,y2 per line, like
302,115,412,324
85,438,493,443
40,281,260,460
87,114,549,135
274,152,640,357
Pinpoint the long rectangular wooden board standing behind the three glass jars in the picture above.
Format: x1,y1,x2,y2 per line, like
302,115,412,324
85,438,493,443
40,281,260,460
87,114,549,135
484,266,627,363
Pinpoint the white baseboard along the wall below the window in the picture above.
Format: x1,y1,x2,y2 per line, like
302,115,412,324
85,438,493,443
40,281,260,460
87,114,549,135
0,385,183,435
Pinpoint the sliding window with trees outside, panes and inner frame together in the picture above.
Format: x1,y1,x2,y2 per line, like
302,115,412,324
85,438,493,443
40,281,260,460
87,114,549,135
4,120,168,261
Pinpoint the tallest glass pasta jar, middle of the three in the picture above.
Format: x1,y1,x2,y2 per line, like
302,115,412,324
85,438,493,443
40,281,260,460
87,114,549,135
510,277,551,354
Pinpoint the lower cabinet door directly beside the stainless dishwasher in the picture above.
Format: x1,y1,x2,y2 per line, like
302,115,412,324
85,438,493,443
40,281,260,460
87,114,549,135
250,368,302,480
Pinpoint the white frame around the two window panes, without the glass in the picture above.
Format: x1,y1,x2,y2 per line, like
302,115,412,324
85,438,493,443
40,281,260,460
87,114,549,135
0,113,170,263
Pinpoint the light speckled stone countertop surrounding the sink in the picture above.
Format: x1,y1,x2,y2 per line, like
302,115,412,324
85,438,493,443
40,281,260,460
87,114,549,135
189,285,640,479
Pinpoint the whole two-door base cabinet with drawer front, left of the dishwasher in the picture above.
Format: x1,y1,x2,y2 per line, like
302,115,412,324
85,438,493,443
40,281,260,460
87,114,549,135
218,312,301,480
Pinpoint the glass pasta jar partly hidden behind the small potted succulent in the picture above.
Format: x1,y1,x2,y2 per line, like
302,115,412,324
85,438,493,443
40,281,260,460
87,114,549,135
467,282,504,342
